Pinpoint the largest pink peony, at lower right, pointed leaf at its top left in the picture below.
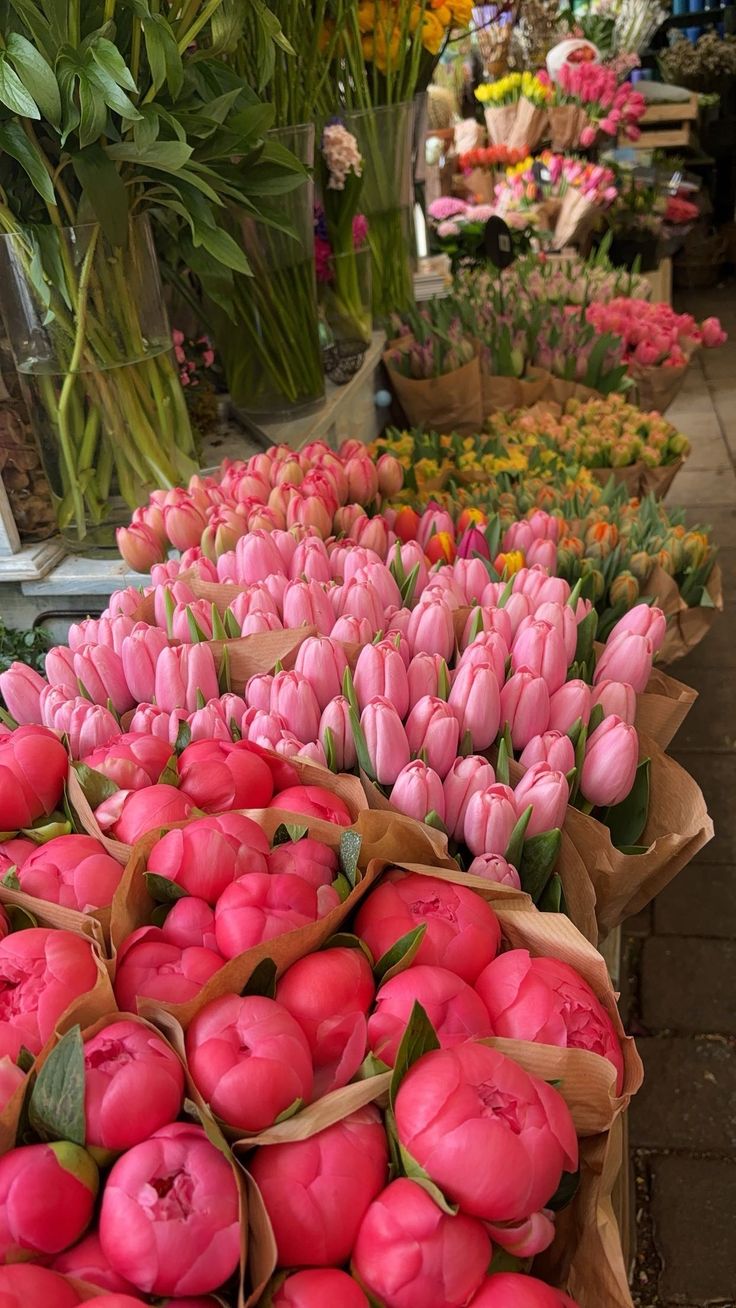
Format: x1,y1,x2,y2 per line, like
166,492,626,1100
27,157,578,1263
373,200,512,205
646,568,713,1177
395,1041,578,1222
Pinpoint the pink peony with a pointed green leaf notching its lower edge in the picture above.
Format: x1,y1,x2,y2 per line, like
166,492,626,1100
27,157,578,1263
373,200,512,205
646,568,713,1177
367,967,493,1067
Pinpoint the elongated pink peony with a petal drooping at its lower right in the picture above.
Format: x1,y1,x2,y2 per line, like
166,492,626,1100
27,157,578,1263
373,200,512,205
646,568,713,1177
276,946,375,1099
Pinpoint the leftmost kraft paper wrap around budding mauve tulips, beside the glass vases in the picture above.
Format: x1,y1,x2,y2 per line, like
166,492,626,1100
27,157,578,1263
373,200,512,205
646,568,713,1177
383,352,482,434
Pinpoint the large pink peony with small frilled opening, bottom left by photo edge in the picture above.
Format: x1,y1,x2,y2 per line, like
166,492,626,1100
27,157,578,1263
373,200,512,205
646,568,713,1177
99,1122,241,1295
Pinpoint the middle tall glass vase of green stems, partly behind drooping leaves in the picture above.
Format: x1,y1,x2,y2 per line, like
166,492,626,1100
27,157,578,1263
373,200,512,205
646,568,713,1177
217,123,324,417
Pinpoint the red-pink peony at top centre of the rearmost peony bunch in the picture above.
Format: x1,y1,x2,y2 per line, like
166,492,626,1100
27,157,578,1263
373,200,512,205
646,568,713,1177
176,740,273,812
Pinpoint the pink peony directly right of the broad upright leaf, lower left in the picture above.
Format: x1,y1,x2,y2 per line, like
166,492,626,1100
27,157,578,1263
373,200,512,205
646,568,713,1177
84,1020,184,1152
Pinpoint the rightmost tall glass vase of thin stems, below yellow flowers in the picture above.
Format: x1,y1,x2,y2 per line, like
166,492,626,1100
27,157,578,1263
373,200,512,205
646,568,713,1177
345,101,414,322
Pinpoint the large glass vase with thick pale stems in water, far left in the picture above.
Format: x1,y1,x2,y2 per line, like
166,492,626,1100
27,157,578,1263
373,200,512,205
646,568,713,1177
0,217,196,548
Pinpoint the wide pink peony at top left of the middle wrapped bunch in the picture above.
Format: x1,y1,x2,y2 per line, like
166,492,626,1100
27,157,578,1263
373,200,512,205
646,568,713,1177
146,810,268,905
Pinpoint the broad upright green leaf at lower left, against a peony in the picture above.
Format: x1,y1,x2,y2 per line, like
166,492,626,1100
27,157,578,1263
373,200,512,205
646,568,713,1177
29,1027,86,1146
